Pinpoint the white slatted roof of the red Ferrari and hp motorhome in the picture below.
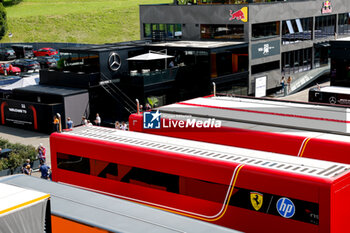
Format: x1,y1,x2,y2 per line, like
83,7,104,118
60,126,350,179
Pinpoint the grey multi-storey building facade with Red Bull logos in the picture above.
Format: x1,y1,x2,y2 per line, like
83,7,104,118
140,0,350,94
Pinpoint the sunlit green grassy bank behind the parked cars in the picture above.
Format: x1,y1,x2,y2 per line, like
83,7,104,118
0,0,172,44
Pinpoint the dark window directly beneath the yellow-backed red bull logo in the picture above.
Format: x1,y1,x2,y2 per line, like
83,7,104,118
201,24,244,40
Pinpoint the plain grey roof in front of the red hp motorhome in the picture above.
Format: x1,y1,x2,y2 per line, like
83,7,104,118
0,175,242,233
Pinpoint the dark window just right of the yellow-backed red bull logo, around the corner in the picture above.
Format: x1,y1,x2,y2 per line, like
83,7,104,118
252,21,280,39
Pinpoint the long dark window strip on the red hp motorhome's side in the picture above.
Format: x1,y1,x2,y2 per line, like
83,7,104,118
57,153,229,202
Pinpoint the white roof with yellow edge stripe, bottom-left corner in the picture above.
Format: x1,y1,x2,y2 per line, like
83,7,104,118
0,183,50,216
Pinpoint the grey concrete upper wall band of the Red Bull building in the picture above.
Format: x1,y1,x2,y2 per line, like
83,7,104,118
140,0,350,27
